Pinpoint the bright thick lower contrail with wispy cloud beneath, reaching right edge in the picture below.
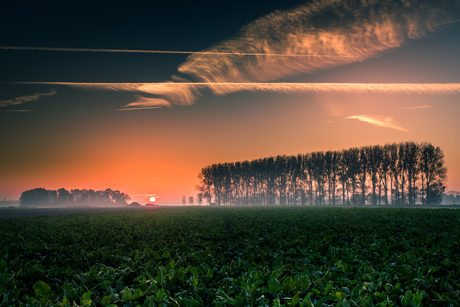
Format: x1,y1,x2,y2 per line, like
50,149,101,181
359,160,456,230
20,82,460,108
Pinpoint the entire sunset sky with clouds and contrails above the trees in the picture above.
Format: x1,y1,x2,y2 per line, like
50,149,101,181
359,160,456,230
0,0,460,204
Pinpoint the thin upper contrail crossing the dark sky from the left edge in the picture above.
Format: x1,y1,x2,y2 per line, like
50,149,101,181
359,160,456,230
0,46,354,58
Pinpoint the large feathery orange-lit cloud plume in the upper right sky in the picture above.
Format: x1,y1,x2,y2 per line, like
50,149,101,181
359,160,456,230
178,0,455,94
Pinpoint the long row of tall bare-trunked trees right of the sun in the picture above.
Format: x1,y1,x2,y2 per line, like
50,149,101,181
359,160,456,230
197,142,447,205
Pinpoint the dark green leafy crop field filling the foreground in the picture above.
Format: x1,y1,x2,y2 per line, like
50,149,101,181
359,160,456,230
0,206,460,307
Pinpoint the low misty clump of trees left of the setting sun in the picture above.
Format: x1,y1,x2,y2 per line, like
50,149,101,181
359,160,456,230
19,188,131,206
